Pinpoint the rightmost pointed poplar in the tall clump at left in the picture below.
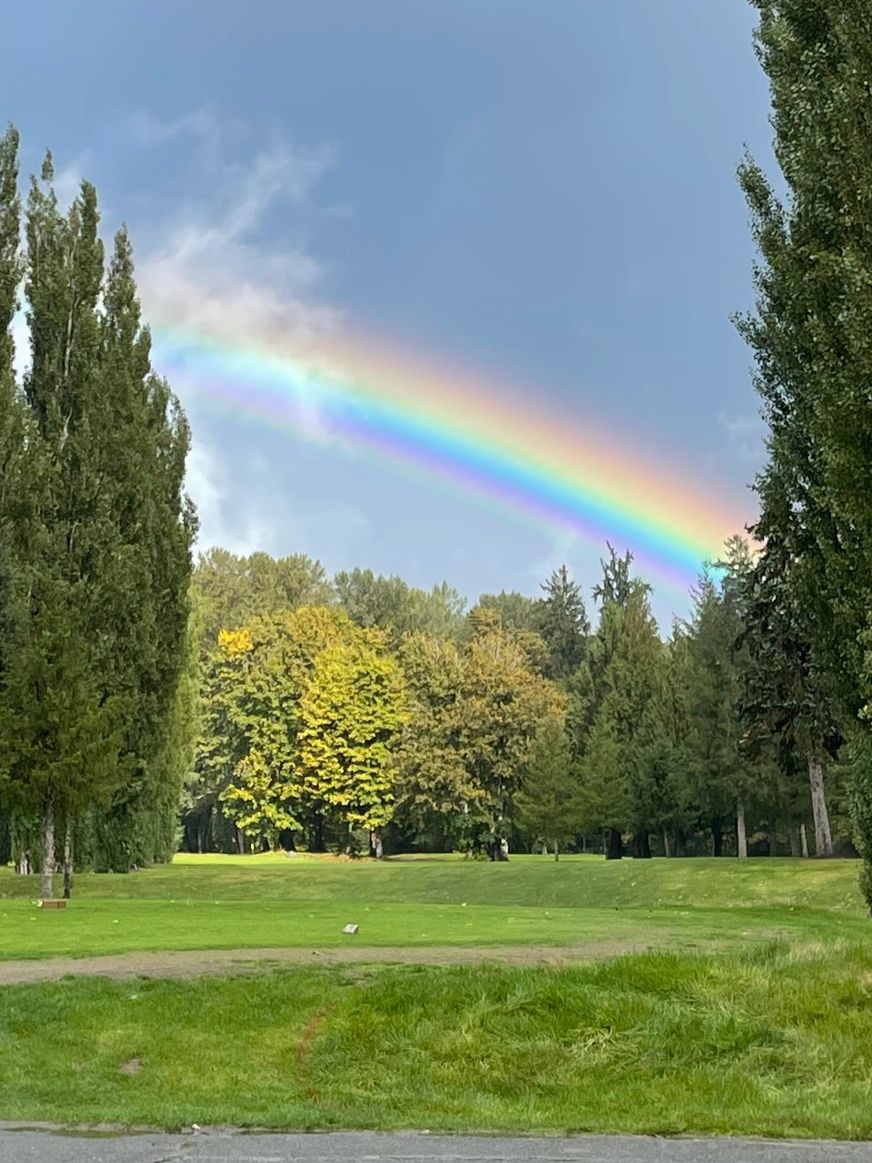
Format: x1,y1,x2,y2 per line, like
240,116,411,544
94,230,195,869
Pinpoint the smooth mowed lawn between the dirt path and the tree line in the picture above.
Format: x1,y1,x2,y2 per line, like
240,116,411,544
0,856,872,959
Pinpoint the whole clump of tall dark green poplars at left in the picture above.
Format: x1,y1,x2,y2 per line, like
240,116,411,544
0,131,194,896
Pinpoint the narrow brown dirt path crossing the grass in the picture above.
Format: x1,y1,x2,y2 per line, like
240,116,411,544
0,940,650,985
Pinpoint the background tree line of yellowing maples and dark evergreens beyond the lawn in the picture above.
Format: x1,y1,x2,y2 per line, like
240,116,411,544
184,536,853,858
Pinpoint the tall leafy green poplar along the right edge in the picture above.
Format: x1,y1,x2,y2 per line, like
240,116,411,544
739,0,872,888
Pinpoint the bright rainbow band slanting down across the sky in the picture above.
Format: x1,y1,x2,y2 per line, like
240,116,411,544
155,321,750,590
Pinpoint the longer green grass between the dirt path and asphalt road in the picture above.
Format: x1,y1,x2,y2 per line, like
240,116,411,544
0,943,872,1139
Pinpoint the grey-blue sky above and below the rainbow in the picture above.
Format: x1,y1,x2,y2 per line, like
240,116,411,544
0,0,770,622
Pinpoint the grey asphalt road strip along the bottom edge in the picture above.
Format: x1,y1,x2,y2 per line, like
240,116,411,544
0,1129,872,1163
